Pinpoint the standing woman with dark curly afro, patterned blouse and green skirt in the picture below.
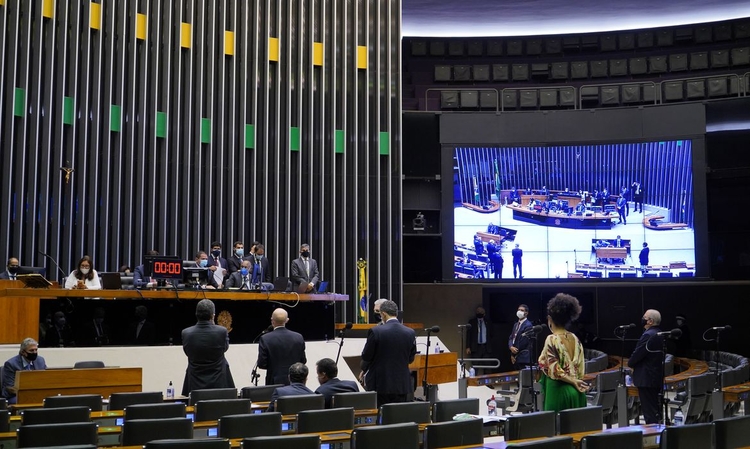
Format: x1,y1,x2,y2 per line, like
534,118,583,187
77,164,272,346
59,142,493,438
539,293,590,412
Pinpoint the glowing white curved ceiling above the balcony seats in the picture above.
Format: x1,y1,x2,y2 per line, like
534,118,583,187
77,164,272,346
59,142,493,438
402,0,750,37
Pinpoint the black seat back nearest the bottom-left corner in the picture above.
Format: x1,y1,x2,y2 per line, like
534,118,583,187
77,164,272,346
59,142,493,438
16,422,98,447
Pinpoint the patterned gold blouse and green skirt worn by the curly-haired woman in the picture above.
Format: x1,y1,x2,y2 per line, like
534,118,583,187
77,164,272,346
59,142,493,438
539,332,586,412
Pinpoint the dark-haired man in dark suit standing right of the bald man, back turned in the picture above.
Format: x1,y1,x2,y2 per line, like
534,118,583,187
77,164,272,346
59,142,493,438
360,300,417,407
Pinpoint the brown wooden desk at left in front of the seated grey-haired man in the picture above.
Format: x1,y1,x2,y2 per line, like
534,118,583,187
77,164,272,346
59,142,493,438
15,368,143,404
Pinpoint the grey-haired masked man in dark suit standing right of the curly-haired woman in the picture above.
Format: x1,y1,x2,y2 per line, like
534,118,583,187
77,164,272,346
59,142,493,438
628,309,664,424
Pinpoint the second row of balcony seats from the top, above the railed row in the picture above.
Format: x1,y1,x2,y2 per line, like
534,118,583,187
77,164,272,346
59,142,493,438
434,47,750,82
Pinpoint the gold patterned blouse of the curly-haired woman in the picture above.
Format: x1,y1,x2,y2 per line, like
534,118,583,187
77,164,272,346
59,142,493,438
539,332,586,380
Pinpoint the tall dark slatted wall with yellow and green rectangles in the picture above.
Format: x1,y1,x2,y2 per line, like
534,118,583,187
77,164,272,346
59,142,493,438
0,0,401,314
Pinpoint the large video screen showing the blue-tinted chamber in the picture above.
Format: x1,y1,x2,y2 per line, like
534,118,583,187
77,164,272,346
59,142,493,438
453,140,696,280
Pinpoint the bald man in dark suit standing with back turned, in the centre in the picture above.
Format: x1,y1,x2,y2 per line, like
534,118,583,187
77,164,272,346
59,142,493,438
258,308,307,385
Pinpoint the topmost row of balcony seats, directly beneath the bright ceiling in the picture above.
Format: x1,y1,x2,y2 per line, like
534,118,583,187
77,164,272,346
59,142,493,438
405,20,750,57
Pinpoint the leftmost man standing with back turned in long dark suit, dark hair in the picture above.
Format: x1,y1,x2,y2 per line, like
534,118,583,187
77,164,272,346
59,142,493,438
182,299,234,396
